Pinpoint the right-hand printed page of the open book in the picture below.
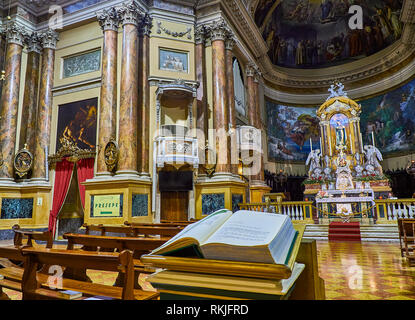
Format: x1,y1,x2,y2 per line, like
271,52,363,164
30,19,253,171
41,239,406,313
200,210,287,246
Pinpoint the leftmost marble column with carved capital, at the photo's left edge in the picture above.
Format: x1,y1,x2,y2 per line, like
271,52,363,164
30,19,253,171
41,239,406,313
0,24,26,181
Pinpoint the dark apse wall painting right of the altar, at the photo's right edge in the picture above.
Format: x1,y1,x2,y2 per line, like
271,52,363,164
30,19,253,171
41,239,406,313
359,80,415,155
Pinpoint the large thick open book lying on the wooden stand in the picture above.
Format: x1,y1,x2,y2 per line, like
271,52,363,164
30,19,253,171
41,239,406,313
151,209,298,264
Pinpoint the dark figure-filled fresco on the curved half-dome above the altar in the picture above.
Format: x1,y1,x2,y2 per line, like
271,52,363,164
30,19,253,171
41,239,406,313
254,0,403,69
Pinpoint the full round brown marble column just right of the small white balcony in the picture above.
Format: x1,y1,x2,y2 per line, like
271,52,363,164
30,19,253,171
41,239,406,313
211,20,231,173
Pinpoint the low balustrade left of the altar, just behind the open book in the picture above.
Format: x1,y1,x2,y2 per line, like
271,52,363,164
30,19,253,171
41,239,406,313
239,201,314,223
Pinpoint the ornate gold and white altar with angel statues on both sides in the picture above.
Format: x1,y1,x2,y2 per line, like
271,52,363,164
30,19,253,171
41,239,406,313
304,83,391,221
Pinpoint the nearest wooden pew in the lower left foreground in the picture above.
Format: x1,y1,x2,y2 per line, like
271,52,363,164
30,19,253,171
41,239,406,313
20,247,158,300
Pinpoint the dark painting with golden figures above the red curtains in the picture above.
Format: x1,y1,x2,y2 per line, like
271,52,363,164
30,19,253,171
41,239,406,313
56,98,98,150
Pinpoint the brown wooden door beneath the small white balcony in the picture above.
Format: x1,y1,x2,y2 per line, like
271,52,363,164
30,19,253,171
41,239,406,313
160,191,189,221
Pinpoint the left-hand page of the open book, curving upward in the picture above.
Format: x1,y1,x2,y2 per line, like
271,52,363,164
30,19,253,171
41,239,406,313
152,209,232,253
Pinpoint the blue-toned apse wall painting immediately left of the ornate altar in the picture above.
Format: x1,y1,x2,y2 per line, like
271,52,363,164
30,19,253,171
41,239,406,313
266,101,320,161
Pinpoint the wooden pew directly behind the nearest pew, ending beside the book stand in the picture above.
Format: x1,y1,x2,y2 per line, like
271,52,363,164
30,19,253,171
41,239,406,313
63,233,170,288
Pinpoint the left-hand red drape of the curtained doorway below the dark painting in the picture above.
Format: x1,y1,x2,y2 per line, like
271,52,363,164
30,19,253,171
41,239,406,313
49,159,74,235
